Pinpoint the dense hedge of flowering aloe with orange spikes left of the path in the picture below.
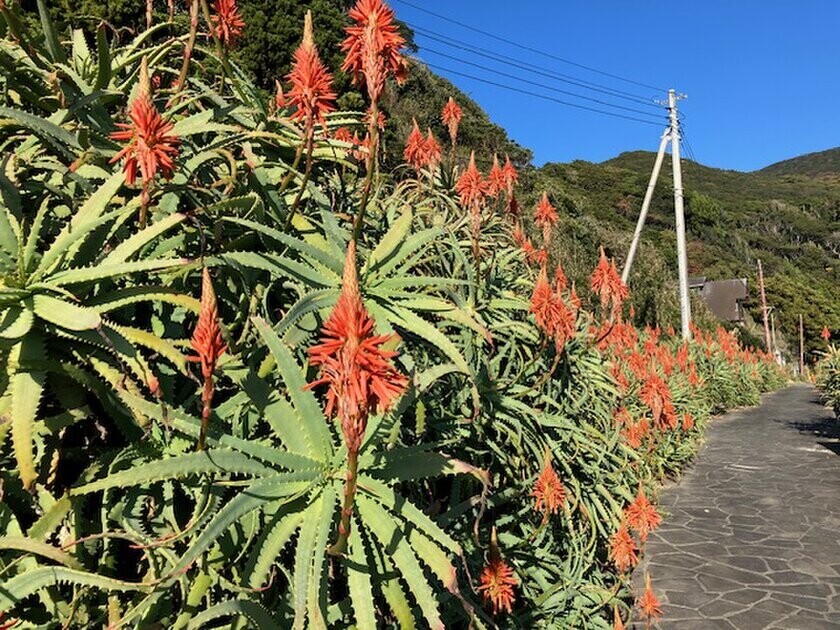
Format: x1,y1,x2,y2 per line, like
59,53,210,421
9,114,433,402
0,0,782,628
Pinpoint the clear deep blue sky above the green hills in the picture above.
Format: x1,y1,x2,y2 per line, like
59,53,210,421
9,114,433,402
390,0,840,170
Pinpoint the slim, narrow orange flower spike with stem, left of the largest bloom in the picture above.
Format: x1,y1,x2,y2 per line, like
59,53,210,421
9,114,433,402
189,267,227,450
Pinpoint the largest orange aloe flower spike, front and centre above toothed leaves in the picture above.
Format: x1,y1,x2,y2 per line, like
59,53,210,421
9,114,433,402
307,241,408,452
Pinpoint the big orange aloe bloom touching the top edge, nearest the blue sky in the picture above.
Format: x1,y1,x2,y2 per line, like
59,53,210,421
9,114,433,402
341,0,408,103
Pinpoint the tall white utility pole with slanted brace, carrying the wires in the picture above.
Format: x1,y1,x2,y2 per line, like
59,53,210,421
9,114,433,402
621,90,691,339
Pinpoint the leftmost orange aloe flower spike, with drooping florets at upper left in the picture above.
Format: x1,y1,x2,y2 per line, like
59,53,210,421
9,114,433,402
109,91,180,186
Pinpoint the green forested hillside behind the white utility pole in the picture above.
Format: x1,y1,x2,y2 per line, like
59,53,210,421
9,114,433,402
539,151,840,360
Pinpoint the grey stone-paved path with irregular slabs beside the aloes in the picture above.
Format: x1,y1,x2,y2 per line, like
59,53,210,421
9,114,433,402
634,385,840,630
